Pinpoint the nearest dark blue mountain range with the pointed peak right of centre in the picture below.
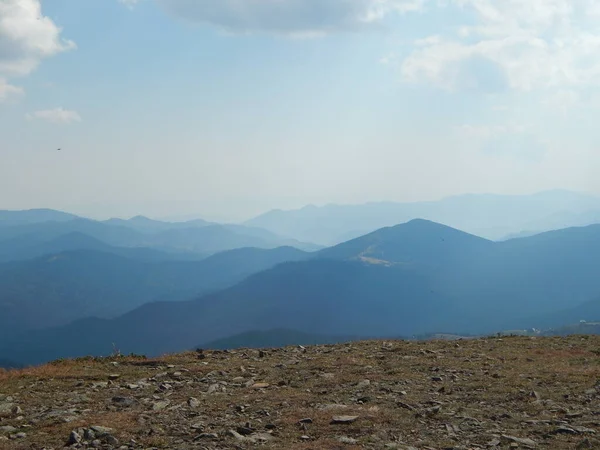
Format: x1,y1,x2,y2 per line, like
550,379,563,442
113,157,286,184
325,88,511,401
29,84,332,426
0,219,600,363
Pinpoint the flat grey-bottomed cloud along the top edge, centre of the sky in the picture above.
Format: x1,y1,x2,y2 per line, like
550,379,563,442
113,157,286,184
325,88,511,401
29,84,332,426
157,0,426,36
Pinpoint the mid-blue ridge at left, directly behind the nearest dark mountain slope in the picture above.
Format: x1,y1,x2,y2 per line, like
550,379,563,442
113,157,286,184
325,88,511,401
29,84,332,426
0,247,307,336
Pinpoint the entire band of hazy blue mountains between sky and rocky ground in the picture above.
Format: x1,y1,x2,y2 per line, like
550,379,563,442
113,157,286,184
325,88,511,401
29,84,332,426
0,191,600,365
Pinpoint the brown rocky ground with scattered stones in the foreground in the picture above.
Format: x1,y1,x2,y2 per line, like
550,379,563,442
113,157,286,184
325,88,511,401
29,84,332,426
0,336,600,449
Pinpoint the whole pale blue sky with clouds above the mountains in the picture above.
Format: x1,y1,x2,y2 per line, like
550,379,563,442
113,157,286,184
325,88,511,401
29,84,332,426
0,0,600,221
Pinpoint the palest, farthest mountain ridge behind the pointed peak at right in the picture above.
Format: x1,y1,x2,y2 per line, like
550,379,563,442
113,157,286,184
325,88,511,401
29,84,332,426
245,190,600,245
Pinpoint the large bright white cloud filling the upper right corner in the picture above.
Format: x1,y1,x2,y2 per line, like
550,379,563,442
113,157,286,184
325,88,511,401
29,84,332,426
401,0,600,91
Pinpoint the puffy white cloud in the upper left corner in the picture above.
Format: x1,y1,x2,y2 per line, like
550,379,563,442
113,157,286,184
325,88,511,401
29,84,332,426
0,0,75,96
